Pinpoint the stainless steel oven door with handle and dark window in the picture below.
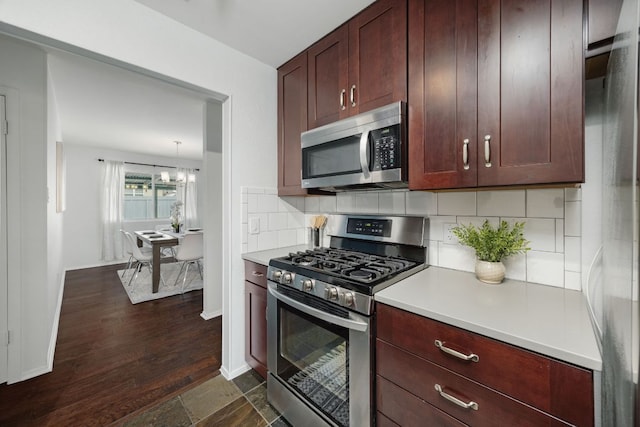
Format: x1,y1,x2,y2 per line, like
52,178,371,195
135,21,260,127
267,282,373,427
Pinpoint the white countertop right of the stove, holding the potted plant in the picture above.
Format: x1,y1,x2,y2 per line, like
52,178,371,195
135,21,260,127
375,267,602,371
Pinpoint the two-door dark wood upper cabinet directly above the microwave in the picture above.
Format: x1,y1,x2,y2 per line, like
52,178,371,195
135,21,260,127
307,0,407,129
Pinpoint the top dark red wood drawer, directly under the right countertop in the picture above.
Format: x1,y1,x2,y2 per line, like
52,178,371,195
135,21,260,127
376,304,593,425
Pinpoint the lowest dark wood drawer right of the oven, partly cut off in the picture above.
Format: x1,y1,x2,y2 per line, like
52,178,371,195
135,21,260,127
376,376,465,427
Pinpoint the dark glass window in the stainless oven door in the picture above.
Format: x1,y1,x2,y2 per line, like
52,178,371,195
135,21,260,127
277,303,349,426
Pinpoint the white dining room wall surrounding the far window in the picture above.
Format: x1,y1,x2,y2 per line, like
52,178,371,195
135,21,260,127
63,144,206,270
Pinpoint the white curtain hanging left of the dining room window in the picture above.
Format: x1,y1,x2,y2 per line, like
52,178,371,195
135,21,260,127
100,160,124,261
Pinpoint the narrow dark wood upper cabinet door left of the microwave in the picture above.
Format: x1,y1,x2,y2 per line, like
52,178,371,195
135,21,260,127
278,53,307,196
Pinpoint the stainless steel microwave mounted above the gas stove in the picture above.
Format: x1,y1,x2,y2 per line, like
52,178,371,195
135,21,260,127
301,102,408,191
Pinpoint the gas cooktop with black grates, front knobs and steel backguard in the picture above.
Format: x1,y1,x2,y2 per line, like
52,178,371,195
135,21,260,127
267,215,428,315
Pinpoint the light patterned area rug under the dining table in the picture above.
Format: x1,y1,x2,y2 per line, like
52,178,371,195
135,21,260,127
118,262,202,304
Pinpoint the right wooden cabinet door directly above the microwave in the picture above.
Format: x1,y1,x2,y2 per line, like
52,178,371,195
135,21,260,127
347,0,407,115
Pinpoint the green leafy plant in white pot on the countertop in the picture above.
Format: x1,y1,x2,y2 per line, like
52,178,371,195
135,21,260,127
451,220,531,283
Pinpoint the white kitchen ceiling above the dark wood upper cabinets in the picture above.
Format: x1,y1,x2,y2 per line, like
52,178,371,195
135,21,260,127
136,0,373,68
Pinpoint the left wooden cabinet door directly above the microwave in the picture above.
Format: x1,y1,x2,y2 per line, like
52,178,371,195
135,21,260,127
307,24,349,129
